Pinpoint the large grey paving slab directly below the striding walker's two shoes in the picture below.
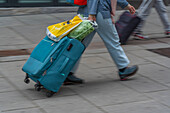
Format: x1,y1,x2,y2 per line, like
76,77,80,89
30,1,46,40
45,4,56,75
72,79,148,106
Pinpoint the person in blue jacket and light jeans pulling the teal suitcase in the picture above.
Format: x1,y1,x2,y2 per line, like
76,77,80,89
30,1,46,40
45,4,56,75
65,0,138,84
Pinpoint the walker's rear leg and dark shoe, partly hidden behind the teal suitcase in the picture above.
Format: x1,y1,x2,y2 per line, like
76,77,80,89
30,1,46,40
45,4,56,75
64,31,96,85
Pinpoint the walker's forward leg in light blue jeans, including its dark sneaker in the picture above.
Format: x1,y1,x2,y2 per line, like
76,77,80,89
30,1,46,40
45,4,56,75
96,13,138,80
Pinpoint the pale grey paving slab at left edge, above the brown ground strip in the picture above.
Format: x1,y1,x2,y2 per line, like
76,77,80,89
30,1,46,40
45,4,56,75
0,28,30,46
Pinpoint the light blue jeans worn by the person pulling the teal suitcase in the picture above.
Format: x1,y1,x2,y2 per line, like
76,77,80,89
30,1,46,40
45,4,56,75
71,12,129,73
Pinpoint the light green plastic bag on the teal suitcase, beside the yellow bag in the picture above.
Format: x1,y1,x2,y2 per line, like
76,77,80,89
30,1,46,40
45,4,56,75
68,20,95,41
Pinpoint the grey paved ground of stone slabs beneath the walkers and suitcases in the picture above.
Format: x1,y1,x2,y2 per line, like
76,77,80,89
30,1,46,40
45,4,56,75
0,7,170,113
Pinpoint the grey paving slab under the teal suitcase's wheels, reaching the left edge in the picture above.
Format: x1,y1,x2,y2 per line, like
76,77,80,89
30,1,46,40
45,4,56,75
0,61,75,100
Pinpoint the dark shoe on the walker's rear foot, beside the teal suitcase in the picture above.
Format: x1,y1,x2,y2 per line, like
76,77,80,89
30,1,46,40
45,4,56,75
64,72,84,85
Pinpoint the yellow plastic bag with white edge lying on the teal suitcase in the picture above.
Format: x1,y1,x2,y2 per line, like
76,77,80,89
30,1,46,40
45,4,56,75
46,15,84,42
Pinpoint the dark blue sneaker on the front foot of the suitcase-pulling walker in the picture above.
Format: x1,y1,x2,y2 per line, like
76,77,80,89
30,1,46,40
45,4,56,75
119,65,138,81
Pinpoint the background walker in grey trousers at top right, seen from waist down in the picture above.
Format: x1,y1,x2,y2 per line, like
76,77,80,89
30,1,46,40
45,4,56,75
134,0,170,39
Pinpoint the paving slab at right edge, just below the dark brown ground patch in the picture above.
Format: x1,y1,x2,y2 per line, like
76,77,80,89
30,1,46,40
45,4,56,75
145,56,170,68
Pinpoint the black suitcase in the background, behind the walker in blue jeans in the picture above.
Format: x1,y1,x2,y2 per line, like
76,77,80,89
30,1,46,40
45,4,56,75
115,11,141,45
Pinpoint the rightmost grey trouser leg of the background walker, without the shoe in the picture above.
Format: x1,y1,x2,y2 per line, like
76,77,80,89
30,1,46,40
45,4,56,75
155,0,170,32
